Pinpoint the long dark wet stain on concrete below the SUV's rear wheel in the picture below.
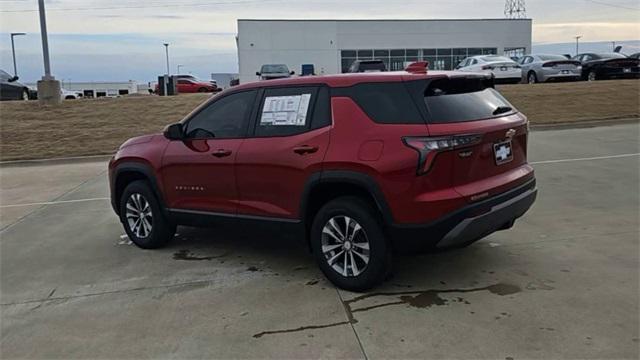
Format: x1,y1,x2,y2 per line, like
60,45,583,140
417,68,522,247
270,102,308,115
253,283,522,339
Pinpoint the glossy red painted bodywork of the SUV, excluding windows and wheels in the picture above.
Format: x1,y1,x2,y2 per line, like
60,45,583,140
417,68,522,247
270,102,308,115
110,71,534,248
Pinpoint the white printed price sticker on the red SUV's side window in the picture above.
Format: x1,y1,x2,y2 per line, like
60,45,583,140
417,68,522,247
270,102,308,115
260,94,311,126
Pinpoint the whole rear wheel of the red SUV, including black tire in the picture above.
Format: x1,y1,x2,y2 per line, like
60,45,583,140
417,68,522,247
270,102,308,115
310,197,391,291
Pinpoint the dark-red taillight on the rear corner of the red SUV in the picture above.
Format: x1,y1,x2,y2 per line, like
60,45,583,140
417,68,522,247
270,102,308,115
402,134,482,175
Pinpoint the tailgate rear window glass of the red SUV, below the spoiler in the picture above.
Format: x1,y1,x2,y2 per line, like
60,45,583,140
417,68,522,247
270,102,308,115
424,78,516,123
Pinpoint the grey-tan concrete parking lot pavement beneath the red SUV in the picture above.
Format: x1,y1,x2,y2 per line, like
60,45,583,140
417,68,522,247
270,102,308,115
0,124,640,359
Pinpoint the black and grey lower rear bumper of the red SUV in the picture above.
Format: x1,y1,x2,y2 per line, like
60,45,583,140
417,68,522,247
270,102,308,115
389,179,538,252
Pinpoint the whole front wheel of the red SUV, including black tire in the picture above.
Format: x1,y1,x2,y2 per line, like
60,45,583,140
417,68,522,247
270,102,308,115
120,180,176,249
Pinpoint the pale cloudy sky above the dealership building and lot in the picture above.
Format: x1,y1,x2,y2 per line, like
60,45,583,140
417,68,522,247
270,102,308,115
0,0,640,81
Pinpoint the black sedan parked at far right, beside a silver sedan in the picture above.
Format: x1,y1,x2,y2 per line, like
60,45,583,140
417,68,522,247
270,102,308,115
573,53,640,81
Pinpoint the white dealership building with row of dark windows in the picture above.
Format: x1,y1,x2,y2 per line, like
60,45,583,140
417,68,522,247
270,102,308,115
237,19,531,83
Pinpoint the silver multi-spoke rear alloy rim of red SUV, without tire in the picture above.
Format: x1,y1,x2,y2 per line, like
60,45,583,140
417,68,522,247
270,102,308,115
321,215,370,277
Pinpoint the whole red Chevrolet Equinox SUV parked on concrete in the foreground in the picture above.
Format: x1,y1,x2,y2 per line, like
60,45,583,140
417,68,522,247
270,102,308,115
109,64,537,291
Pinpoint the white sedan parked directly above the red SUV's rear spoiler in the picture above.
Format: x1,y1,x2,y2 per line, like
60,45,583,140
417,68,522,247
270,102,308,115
456,55,522,84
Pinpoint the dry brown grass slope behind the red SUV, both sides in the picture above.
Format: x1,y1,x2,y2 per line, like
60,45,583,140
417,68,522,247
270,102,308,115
0,80,640,161
